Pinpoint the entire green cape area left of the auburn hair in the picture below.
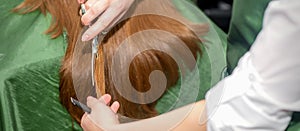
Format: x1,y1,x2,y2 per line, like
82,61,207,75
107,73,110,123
0,0,79,131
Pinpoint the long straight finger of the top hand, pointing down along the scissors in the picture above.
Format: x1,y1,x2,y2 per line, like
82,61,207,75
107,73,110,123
82,3,122,41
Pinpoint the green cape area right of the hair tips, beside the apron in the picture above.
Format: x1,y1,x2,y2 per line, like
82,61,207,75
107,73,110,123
156,0,226,113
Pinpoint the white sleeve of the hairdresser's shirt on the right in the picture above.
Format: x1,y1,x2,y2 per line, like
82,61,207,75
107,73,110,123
206,0,300,131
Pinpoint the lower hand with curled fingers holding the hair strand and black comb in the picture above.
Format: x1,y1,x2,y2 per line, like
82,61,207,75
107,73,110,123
81,95,120,131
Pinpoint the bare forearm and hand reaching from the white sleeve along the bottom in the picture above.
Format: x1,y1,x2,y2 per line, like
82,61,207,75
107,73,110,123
81,94,206,131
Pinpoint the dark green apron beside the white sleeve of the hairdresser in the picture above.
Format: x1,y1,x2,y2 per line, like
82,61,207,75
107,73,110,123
227,0,300,131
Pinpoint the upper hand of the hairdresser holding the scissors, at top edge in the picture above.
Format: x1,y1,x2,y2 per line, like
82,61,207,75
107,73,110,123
81,0,134,41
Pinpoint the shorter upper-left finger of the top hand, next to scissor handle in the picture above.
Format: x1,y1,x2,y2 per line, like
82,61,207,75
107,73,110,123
81,0,109,25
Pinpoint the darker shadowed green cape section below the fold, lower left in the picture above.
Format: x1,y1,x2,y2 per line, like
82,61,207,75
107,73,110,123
1,57,80,131
